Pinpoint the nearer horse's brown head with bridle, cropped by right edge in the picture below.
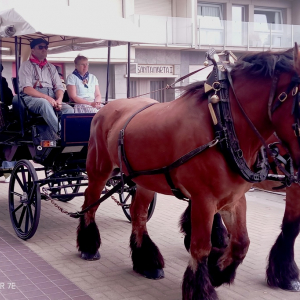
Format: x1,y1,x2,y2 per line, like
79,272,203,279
269,44,300,169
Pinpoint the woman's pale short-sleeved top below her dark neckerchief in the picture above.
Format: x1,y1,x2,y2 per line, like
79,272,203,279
67,74,99,102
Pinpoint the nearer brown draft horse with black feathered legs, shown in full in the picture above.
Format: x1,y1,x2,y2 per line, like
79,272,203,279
77,48,300,300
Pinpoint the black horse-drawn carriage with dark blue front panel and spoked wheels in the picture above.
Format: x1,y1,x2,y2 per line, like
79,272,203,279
0,10,156,240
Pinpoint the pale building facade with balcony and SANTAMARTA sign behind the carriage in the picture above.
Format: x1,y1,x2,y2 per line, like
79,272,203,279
0,0,300,102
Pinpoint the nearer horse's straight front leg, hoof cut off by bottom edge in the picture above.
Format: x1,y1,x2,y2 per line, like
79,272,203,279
182,197,218,300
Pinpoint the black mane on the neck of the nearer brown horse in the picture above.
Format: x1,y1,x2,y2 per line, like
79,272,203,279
181,49,294,99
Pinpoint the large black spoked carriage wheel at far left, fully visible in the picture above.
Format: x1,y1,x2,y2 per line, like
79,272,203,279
8,159,41,240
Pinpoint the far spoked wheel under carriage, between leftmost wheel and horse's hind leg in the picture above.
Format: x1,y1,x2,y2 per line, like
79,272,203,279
45,169,81,202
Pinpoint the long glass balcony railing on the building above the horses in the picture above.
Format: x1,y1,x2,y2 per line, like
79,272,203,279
130,15,300,50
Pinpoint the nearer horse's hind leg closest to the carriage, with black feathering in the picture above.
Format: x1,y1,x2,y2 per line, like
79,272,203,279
77,141,112,260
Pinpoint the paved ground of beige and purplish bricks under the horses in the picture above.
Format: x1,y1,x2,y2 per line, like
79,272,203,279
0,177,300,300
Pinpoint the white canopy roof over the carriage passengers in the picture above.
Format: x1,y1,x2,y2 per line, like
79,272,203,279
0,6,156,53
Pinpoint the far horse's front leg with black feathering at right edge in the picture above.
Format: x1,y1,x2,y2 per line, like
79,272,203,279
267,184,300,292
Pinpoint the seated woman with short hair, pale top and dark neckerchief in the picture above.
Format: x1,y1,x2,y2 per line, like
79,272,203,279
67,55,101,113
